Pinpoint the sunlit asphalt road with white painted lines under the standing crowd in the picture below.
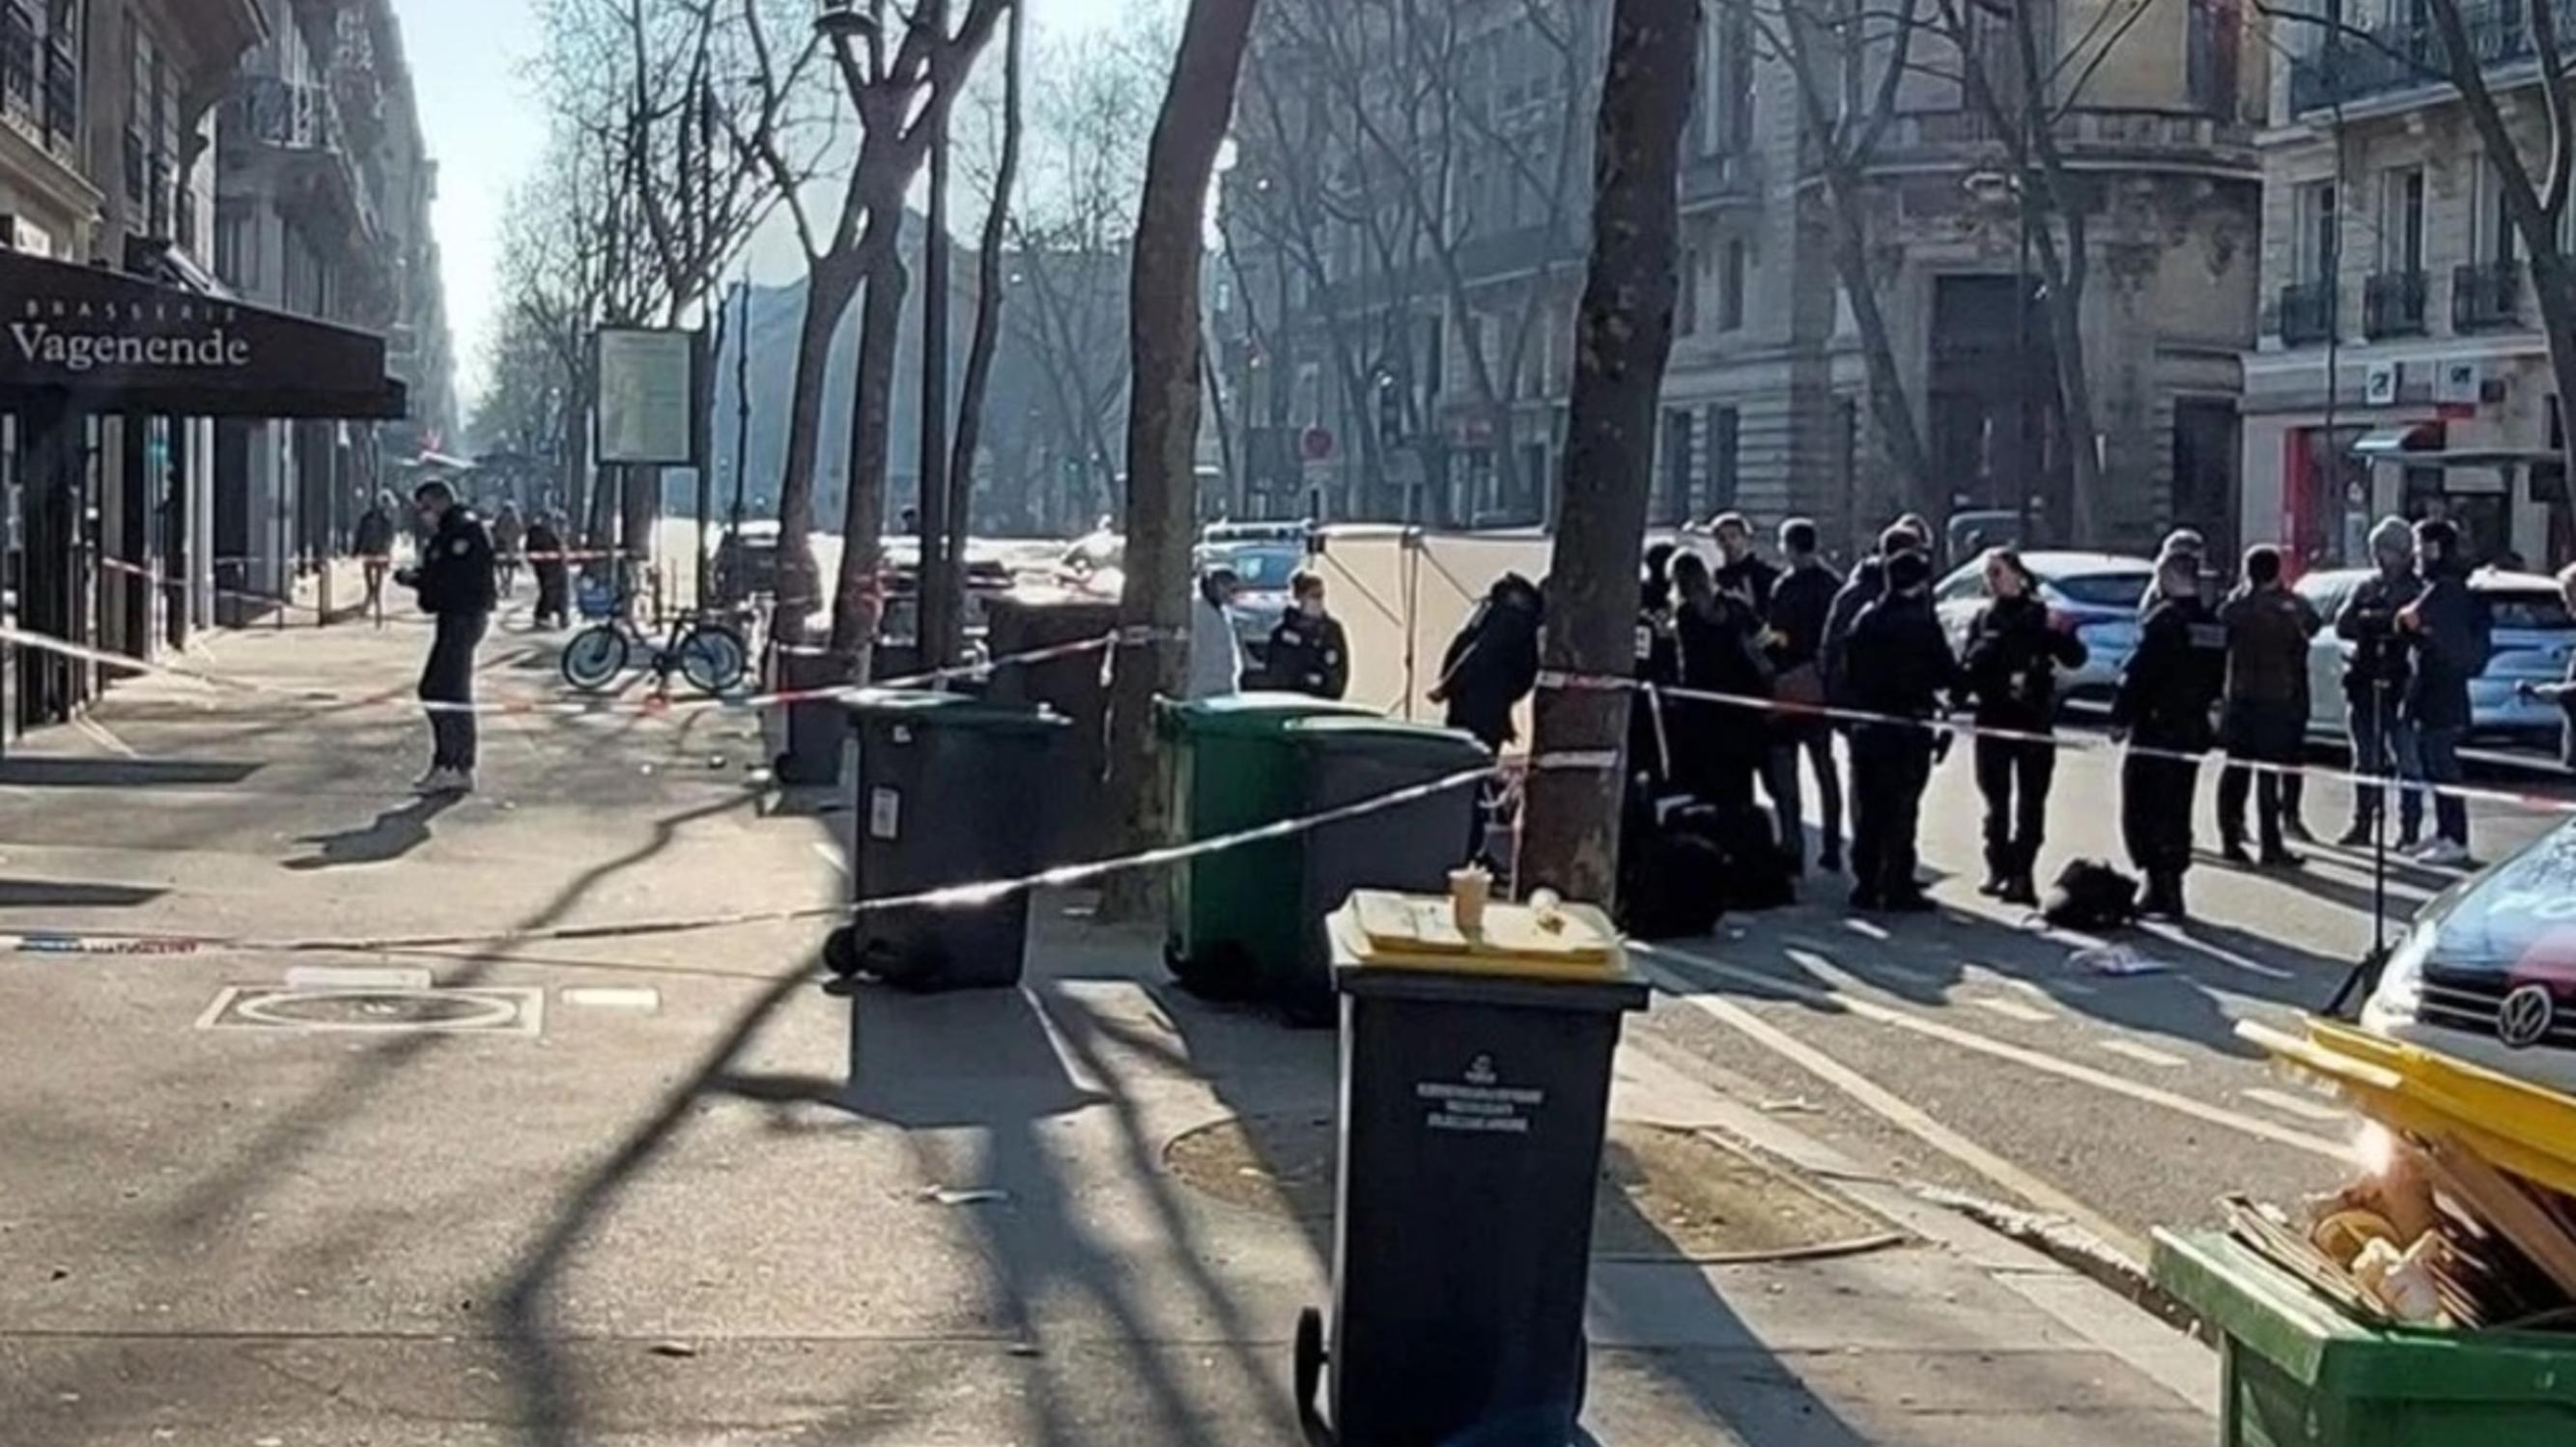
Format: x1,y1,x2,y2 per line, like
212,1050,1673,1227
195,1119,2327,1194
1644,734,2571,1254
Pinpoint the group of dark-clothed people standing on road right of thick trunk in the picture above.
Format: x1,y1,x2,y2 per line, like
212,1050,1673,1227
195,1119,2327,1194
1630,501,2524,920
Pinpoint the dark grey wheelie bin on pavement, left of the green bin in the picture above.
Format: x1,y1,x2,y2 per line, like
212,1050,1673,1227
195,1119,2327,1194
824,690,1069,991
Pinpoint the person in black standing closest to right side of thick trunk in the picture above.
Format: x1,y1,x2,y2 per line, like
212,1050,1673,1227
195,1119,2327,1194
1667,553,1772,811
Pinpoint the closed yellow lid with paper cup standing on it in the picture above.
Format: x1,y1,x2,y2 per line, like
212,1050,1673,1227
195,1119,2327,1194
1332,889,1636,983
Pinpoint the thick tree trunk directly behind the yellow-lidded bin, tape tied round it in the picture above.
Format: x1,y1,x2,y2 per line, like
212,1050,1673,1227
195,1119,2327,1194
1520,0,1700,904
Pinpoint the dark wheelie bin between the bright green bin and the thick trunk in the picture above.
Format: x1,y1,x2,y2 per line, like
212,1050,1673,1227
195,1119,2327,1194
1260,713,1494,1028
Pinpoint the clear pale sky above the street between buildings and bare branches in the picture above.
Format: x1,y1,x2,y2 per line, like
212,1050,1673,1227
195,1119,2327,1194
394,0,1131,407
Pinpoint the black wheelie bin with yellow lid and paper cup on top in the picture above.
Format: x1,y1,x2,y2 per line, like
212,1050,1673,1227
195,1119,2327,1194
1298,891,1646,1447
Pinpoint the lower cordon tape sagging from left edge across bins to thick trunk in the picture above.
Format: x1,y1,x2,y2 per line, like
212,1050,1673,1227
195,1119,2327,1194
0,762,1507,955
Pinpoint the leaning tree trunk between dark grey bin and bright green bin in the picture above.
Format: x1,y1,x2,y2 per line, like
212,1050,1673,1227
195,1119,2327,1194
1100,0,1261,920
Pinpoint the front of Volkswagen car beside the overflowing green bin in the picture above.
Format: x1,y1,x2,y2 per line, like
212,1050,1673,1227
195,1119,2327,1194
2363,821,2576,1089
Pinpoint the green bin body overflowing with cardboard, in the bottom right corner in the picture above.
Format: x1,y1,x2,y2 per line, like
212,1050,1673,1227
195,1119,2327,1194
2156,1231,2576,1447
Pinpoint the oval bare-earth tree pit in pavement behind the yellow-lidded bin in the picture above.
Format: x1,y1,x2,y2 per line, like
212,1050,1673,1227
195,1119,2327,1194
1162,1115,1893,1262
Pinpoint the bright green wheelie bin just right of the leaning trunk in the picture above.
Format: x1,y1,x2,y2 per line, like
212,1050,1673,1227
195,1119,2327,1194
1159,693,1373,999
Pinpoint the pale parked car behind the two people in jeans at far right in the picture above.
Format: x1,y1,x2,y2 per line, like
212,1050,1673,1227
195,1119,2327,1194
2298,569,2576,739
